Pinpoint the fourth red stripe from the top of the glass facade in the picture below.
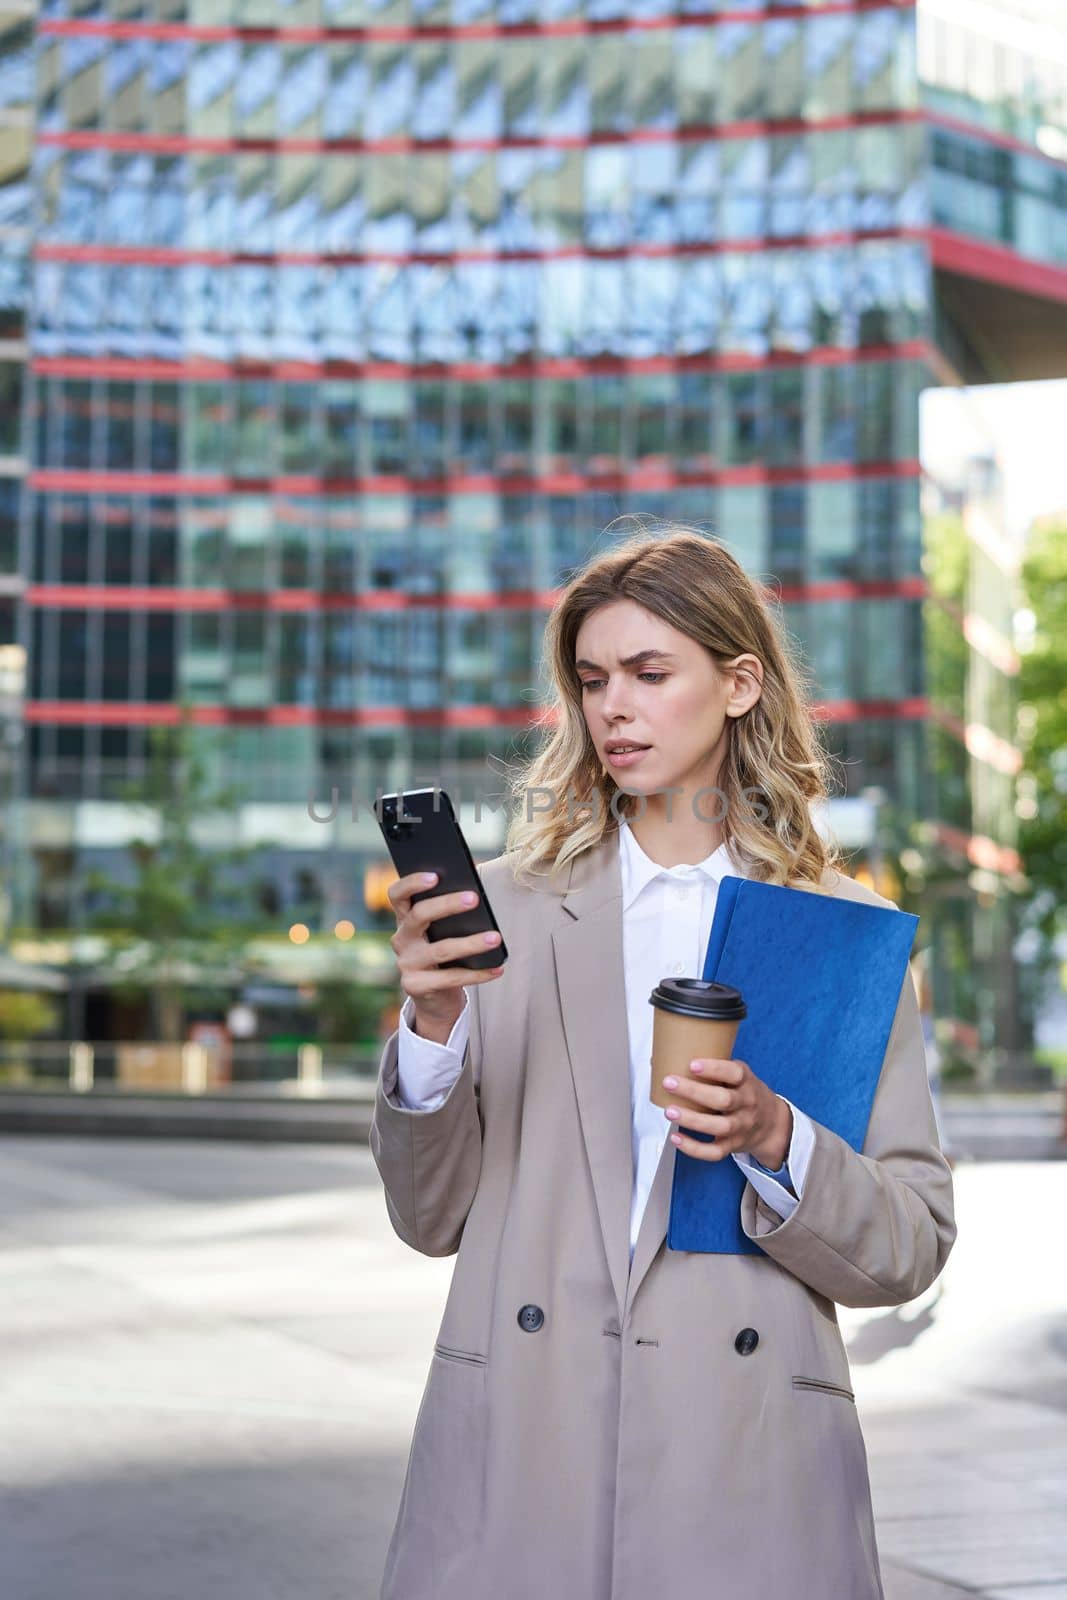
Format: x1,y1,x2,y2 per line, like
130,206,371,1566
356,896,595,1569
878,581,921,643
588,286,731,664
29,339,937,382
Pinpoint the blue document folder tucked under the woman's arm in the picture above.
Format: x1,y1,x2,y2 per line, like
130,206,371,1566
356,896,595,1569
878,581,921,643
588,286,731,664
667,878,918,1254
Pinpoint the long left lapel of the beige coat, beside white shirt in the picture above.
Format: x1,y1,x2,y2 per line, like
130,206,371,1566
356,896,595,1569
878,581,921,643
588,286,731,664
552,832,633,1326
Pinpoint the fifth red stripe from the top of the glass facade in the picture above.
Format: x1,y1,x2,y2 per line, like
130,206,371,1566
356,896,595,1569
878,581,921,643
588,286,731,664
27,458,921,499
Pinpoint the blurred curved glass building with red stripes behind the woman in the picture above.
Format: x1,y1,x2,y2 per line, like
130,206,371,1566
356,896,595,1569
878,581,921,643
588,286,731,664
0,0,1067,1075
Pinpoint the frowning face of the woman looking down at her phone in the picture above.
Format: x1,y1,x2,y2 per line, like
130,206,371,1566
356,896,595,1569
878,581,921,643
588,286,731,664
574,600,763,794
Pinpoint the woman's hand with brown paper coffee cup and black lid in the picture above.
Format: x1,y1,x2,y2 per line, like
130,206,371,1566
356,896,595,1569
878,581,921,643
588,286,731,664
649,978,793,1170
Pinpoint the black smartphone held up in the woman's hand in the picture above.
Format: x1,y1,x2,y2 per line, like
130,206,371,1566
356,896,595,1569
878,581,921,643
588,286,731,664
374,789,507,968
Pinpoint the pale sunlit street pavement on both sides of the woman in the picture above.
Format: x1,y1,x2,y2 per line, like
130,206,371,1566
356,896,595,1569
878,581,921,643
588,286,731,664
0,1136,1067,1600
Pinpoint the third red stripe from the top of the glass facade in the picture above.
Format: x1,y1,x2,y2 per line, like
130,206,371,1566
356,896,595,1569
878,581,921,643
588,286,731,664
34,227,928,267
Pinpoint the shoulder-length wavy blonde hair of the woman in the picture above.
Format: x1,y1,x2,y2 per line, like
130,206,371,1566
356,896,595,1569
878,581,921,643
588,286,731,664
504,531,838,888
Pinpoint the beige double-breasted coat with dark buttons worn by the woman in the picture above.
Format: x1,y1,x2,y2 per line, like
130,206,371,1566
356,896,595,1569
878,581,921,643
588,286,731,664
371,835,955,1600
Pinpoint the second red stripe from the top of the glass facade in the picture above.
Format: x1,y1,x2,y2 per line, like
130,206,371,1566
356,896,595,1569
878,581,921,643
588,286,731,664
37,109,925,155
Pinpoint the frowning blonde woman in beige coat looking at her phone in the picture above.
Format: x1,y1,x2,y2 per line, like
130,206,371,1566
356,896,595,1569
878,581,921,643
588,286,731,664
371,528,955,1600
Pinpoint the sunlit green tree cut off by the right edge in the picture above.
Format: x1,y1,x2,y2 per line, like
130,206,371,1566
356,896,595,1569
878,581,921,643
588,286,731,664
1019,520,1067,952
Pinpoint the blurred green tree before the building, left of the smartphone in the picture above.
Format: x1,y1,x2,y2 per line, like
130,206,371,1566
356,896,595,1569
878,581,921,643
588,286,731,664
85,707,279,1043
